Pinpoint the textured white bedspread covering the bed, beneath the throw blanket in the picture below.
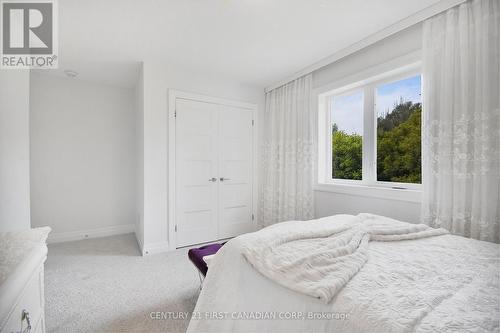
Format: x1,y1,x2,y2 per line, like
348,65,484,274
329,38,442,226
188,216,500,333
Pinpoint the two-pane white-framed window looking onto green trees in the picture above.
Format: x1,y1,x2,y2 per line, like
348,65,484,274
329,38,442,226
319,68,422,189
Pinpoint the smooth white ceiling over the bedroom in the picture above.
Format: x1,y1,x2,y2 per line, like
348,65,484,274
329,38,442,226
48,0,440,87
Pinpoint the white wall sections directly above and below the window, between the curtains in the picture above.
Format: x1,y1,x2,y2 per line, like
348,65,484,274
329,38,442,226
313,24,422,222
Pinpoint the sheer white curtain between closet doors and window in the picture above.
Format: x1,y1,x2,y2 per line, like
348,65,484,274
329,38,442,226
260,74,314,226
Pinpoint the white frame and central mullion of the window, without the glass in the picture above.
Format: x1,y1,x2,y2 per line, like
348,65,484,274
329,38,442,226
317,62,423,192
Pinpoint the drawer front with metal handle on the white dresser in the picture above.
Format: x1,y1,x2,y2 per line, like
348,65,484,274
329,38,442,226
0,266,43,333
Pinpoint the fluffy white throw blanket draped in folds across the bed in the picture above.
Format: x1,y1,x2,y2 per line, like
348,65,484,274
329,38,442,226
242,214,448,303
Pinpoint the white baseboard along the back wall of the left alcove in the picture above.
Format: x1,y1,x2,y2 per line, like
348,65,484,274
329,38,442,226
47,224,135,243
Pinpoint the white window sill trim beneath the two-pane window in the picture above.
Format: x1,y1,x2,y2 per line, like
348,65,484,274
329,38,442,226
314,183,422,203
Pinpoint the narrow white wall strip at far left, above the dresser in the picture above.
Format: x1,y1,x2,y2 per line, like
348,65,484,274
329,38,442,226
0,70,30,231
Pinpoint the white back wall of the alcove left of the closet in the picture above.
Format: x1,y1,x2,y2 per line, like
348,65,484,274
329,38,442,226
30,74,136,241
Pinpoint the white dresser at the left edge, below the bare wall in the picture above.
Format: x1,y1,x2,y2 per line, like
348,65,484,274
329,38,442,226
0,228,50,333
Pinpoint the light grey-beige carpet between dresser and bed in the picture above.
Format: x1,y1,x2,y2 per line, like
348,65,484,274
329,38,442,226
45,234,199,333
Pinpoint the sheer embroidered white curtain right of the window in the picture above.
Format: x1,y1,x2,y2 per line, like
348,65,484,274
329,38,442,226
422,0,500,243
